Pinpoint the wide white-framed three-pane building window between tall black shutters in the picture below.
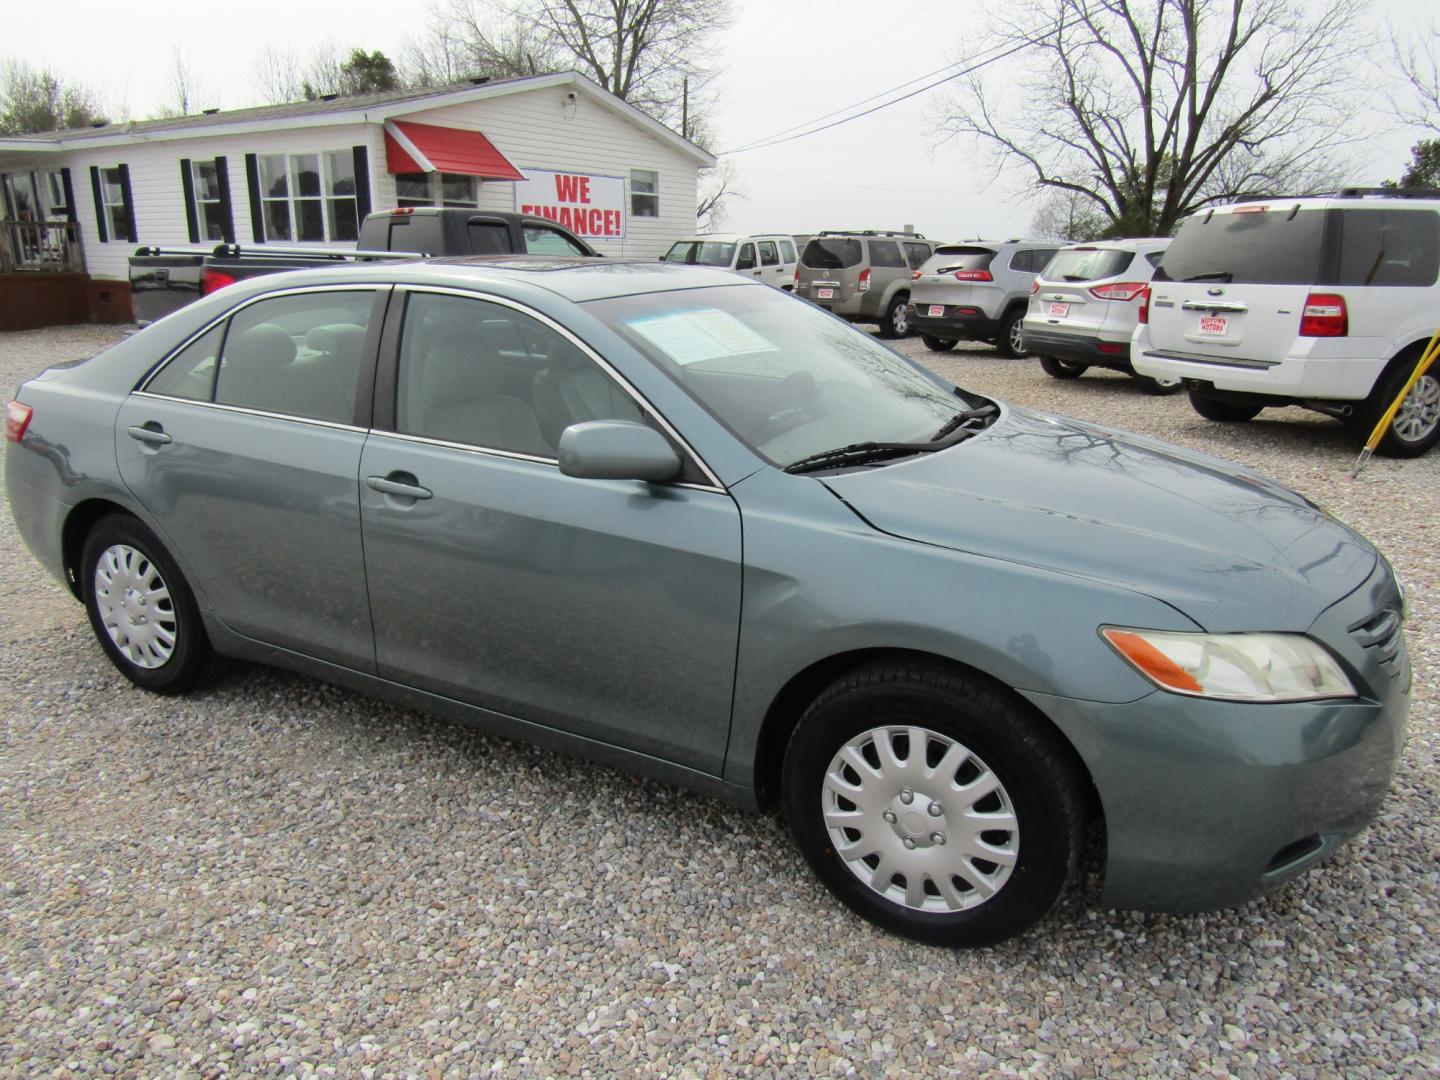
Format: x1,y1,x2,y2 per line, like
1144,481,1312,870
259,150,360,242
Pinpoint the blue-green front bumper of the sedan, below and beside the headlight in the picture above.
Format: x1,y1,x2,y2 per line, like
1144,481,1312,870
1025,560,1411,912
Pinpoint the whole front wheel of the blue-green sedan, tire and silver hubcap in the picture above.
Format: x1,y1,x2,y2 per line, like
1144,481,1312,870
785,664,1083,948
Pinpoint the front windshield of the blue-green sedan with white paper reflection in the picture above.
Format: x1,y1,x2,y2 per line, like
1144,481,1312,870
586,285,985,468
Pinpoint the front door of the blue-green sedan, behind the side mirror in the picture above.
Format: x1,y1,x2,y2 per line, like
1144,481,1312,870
360,289,742,773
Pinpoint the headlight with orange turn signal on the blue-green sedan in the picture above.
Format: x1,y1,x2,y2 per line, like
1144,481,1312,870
1100,626,1355,701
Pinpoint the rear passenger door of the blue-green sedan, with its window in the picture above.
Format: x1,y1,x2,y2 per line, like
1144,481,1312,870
115,287,387,671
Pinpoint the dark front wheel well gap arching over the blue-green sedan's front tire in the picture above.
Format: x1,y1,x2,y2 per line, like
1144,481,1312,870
755,649,1104,827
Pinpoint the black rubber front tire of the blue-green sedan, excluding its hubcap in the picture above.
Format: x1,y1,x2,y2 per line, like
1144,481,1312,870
783,662,1084,948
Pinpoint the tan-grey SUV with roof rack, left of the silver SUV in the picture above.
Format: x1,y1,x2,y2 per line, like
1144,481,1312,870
795,229,935,337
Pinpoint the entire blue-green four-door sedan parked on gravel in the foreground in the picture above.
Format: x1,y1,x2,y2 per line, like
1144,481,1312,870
4,256,1411,945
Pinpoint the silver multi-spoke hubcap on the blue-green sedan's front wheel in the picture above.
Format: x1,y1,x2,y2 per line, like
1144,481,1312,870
821,726,1020,913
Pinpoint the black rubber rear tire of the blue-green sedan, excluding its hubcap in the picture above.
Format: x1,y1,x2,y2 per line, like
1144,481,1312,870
79,514,212,694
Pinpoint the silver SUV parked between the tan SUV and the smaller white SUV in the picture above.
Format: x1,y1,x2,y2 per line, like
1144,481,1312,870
910,240,1060,356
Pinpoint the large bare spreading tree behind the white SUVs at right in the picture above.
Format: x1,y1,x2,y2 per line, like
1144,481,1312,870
937,0,1367,236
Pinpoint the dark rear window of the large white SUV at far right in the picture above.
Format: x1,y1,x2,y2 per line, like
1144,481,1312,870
1155,204,1325,285
